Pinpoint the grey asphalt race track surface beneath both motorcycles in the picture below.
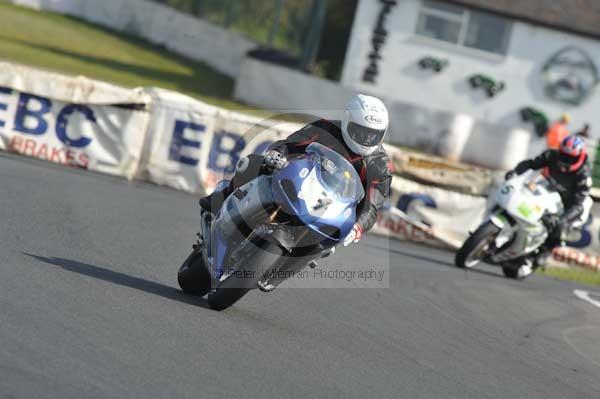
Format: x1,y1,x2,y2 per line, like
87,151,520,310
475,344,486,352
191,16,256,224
0,155,600,399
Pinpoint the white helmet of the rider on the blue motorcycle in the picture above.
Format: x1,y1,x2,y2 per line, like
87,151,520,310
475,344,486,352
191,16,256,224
342,94,389,156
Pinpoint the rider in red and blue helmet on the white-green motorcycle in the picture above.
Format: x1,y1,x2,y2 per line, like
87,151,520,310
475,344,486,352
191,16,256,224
506,136,592,266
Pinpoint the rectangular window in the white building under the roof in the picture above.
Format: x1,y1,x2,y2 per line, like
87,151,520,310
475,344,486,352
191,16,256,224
417,0,511,54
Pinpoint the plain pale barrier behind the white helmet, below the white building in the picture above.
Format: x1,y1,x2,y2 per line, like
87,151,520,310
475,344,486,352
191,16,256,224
235,57,545,170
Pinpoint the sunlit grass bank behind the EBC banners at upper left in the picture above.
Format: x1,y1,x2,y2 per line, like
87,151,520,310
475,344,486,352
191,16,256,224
0,0,249,109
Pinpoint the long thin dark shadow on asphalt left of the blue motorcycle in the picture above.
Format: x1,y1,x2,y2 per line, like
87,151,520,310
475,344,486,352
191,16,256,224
21,252,209,309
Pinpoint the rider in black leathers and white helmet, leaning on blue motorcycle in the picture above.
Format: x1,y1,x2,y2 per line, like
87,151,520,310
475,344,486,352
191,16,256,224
200,95,392,245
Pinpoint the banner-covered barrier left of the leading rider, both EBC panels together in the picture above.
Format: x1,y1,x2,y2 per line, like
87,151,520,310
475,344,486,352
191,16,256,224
0,63,310,194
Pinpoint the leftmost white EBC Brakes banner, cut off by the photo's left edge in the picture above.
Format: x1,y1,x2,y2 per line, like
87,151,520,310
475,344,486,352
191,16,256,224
0,64,149,179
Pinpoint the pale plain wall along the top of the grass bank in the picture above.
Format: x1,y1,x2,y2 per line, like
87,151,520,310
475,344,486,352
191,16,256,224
11,0,257,77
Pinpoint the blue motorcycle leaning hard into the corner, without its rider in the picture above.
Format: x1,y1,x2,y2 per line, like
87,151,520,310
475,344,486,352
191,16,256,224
178,143,365,310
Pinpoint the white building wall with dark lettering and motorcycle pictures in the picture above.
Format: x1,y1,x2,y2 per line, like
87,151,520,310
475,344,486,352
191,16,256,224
342,0,600,137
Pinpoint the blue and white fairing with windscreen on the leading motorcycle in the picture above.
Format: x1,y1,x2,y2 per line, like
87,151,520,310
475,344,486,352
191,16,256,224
208,143,364,279
